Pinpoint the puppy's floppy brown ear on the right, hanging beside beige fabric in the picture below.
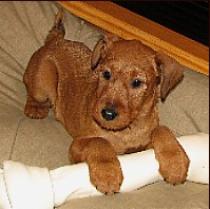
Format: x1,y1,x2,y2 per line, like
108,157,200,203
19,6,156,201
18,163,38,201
155,53,184,101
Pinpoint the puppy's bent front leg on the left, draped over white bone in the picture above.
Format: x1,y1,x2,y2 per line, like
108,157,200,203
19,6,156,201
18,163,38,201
70,138,123,194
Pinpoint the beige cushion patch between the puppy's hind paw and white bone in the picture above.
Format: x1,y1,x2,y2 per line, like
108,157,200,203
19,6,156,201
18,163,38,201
11,117,72,169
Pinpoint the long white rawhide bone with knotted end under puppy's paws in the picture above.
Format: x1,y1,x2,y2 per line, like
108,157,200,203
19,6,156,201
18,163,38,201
0,133,209,209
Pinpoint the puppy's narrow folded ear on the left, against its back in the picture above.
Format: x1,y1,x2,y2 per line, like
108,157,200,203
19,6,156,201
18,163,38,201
91,33,121,69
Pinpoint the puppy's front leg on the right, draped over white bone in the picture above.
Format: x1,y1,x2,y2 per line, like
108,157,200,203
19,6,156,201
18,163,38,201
152,126,189,185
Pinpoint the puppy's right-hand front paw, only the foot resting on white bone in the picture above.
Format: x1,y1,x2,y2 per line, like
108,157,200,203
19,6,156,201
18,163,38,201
158,151,189,185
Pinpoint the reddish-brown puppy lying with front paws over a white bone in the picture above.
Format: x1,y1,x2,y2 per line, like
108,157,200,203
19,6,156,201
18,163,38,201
24,13,189,194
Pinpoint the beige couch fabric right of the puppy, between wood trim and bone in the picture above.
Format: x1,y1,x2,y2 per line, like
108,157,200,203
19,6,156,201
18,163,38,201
159,69,209,136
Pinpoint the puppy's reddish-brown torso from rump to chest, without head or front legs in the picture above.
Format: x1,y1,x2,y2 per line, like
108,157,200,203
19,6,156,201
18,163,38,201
24,37,158,154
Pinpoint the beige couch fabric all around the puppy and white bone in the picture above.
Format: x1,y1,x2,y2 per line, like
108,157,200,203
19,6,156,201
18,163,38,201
0,1,209,209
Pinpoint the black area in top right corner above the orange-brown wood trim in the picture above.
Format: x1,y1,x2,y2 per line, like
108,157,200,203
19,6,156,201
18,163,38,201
113,0,209,45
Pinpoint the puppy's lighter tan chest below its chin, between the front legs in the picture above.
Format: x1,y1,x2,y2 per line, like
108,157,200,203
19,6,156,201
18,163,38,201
72,112,159,154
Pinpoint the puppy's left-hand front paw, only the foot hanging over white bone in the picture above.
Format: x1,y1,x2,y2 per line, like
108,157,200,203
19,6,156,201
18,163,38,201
89,159,123,194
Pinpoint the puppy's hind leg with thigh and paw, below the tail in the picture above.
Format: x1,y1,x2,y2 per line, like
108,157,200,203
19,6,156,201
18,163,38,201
23,49,57,119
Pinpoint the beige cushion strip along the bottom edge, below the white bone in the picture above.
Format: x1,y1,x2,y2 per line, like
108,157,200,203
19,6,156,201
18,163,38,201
62,182,208,209
